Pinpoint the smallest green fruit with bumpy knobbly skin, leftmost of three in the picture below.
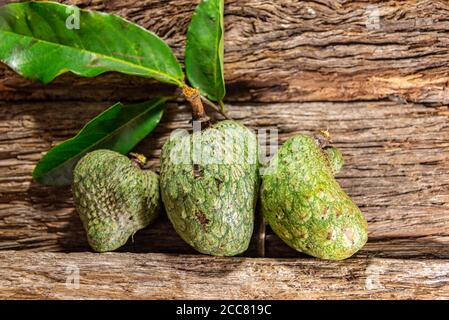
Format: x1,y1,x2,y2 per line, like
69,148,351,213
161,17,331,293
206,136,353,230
72,150,160,252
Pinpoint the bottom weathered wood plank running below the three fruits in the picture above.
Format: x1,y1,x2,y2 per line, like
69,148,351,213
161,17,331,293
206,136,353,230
0,251,449,299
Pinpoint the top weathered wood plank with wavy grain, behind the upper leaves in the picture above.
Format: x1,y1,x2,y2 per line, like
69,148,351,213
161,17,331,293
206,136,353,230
0,0,449,104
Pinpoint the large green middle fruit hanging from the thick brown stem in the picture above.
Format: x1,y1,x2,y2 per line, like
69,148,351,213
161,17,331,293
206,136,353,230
161,120,259,256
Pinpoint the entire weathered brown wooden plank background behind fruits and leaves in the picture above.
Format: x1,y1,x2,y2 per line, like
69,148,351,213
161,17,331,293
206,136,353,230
0,0,449,299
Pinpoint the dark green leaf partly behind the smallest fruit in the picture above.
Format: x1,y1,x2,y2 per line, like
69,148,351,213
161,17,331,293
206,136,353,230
33,98,167,186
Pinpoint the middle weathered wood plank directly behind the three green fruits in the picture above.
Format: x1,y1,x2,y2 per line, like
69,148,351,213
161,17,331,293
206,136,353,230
0,102,449,258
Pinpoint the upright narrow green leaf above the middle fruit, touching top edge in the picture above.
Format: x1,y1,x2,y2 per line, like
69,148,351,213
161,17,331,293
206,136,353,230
185,0,226,105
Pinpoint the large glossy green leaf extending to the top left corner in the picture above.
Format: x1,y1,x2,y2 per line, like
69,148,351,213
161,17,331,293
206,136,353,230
0,2,184,86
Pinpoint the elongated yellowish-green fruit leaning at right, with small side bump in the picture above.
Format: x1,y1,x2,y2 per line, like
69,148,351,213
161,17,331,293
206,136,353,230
261,134,368,260
